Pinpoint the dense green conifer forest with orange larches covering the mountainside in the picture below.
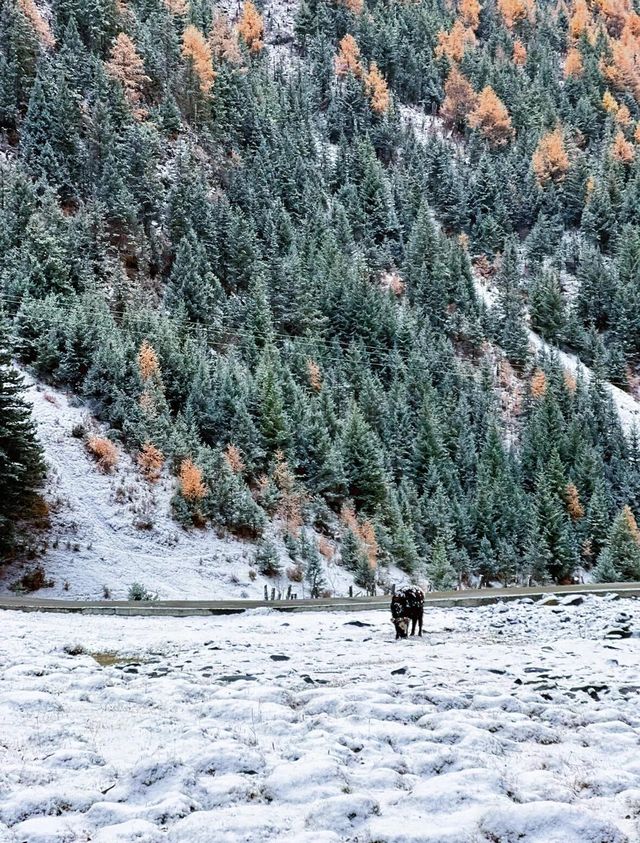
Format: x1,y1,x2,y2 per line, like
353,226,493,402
0,0,640,587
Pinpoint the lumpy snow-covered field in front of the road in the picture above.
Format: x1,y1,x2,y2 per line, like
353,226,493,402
0,597,640,843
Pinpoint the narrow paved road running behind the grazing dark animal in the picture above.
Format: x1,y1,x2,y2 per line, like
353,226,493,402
0,582,640,617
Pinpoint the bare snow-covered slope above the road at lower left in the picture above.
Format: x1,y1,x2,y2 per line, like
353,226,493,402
0,376,362,599
